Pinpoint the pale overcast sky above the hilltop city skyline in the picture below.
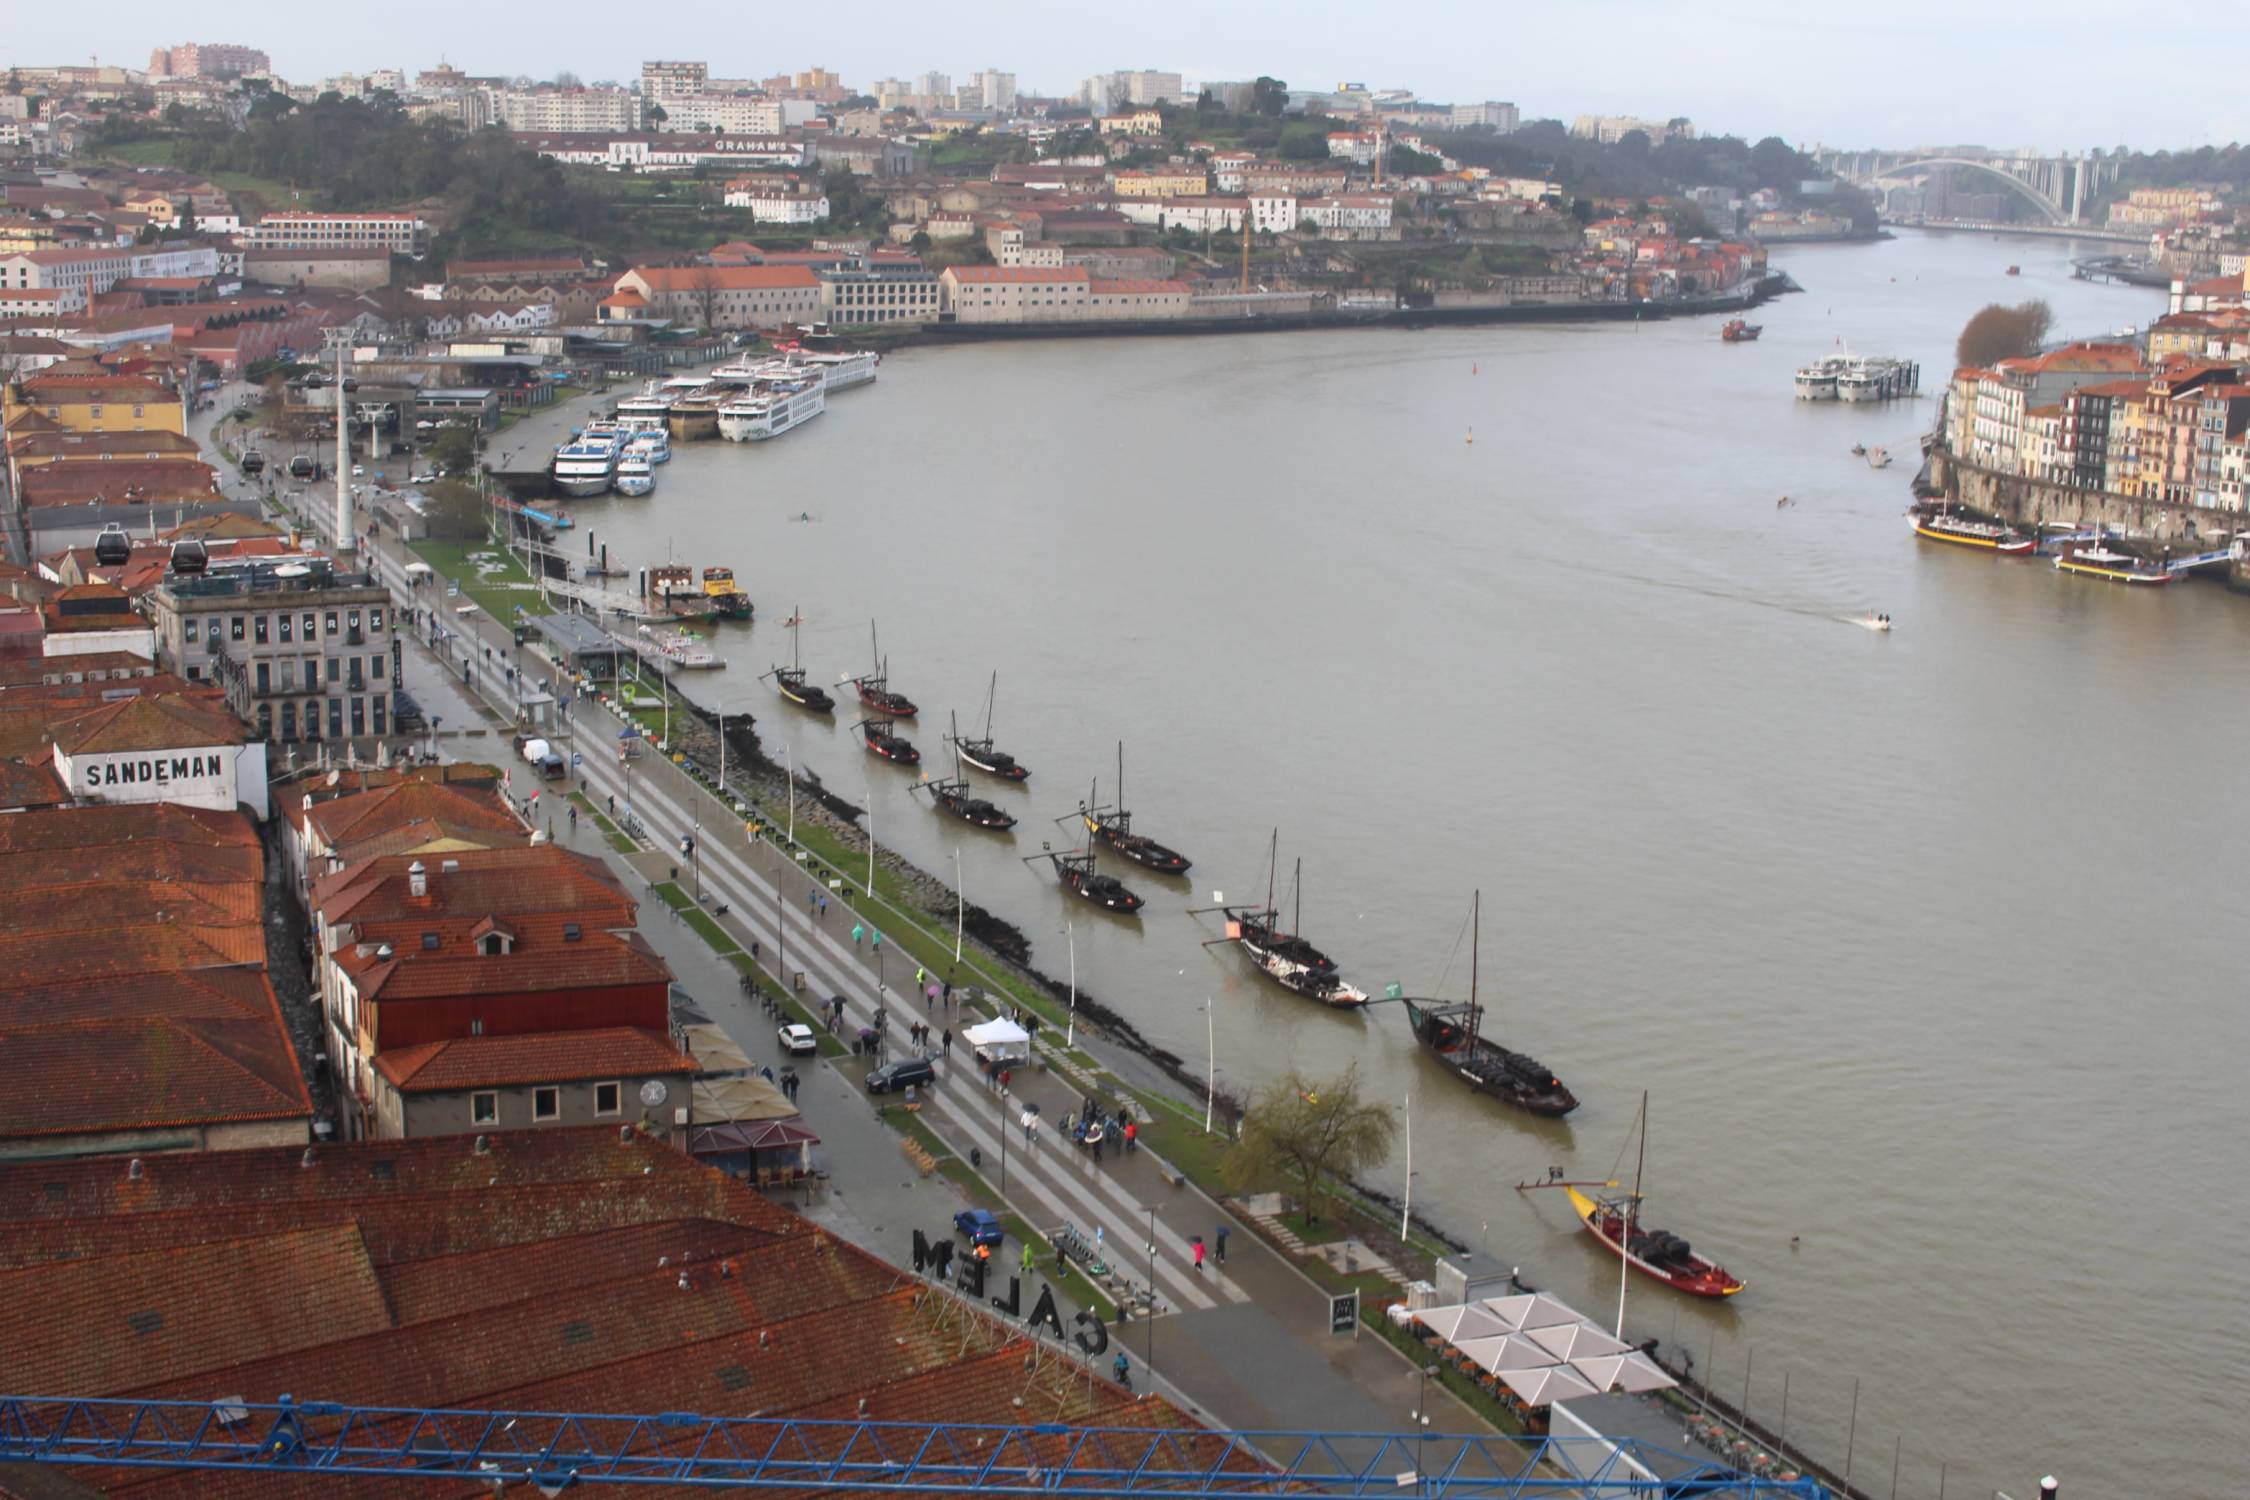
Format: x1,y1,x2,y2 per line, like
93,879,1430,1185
0,0,2250,151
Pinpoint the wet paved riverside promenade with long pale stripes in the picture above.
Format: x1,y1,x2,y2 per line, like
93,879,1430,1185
333,465,1483,1433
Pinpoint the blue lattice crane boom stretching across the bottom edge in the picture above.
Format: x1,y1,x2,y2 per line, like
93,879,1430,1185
0,1397,1827,1500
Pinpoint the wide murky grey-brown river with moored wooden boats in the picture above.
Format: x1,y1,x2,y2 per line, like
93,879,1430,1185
515,234,2250,1496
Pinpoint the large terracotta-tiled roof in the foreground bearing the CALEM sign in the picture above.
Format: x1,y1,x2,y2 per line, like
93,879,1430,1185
0,1127,1193,1500
